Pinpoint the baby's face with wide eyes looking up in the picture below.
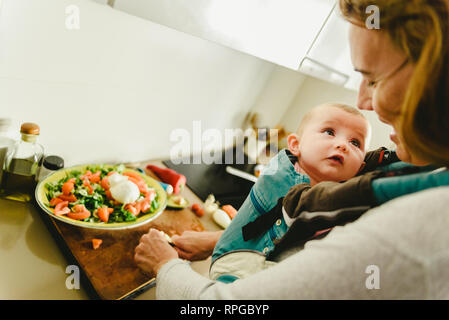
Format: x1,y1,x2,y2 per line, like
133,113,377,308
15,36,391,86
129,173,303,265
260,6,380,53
289,106,369,184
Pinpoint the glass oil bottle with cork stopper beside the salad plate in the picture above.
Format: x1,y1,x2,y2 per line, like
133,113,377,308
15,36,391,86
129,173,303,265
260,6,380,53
1,122,44,202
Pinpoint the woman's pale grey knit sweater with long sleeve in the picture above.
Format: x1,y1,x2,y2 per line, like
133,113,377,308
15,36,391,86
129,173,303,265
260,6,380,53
156,187,449,300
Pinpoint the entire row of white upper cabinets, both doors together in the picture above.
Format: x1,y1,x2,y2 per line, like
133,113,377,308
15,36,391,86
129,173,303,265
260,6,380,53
108,0,361,90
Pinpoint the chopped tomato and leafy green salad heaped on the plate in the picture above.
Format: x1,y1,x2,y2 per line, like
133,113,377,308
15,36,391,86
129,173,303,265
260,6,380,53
45,165,159,223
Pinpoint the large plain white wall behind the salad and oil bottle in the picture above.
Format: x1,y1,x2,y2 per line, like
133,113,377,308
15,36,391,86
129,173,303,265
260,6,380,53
0,0,275,165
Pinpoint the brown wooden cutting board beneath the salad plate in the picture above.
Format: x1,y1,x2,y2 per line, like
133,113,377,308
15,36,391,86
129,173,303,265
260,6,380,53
36,163,205,300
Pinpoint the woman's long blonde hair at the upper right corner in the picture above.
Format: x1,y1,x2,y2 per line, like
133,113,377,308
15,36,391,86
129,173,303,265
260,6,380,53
339,0,449,165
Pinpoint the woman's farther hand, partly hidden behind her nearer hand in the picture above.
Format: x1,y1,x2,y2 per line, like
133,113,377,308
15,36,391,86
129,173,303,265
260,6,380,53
171,231,223,261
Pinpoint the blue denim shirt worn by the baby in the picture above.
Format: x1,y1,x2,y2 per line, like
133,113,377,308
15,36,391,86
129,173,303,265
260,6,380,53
212,149,310,262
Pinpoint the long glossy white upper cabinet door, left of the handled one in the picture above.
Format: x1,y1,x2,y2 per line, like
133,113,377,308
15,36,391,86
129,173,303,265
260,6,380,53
109,0,335,70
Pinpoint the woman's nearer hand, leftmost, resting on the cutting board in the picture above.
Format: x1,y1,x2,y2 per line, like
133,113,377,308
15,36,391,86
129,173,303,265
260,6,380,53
134,229,178,275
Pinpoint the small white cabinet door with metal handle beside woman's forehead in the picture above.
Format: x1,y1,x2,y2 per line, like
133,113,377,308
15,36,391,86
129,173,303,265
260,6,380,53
298,6,361,90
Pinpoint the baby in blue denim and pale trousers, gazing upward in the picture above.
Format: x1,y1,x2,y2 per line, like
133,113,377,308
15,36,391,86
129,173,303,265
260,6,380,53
210,103,371,282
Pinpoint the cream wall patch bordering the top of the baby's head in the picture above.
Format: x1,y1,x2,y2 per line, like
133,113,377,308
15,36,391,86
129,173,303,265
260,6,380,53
280,77,394,149
